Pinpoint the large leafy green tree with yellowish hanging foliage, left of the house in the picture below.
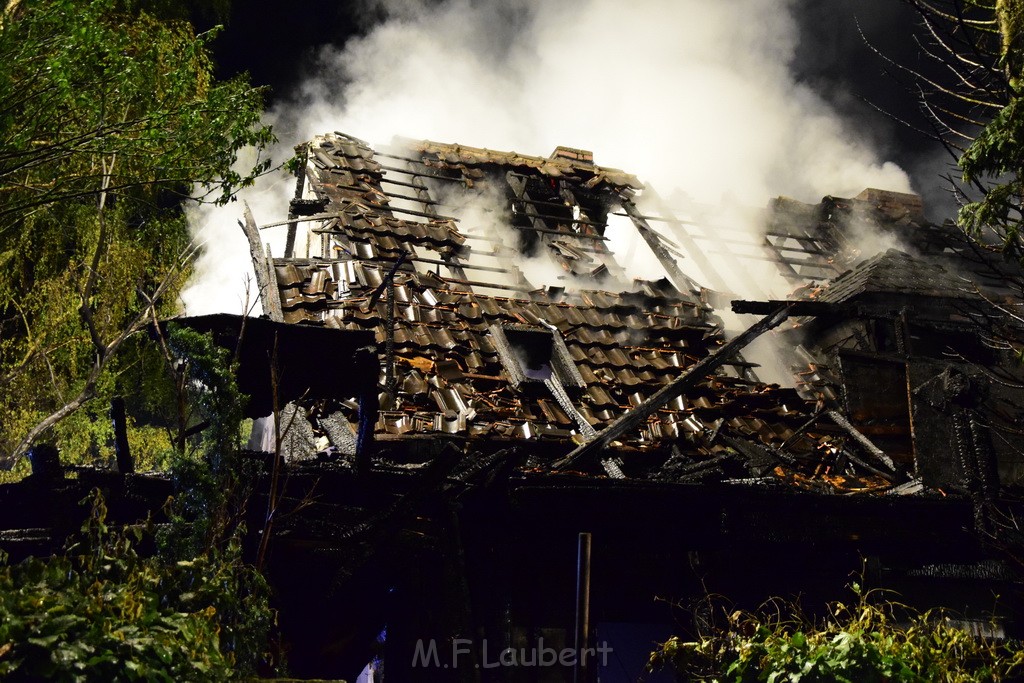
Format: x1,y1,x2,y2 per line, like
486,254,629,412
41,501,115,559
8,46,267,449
0,0,272,463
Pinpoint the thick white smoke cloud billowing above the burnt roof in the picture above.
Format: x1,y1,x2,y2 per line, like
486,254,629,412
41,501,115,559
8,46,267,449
178,0,910,313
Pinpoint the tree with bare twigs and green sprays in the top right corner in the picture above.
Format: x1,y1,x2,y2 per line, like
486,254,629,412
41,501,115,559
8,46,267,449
894,0,1024,260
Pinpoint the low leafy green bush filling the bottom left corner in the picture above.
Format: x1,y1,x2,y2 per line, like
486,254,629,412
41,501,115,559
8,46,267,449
0,494,232,682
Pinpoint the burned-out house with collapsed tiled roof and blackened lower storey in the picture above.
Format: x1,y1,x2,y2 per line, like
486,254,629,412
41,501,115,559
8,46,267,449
220,133,1024,680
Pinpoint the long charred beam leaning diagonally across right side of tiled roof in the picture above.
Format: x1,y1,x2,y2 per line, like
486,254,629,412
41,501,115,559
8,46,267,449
552,302,793,470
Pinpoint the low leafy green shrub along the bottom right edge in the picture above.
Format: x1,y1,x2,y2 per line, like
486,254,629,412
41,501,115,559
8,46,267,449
648,585,1024,683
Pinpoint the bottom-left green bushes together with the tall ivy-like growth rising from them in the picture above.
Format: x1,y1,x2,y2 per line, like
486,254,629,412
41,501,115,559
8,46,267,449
0,326,275,681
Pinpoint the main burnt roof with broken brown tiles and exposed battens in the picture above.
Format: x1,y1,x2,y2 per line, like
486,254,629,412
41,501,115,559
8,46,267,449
253,135,799,454
